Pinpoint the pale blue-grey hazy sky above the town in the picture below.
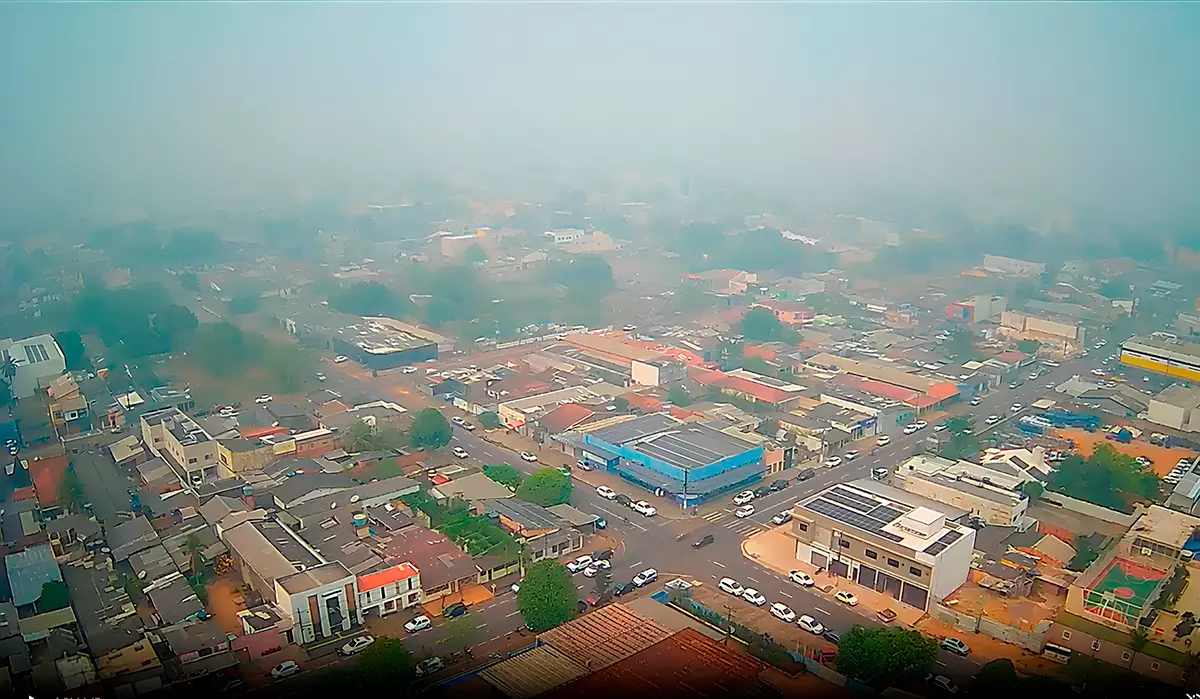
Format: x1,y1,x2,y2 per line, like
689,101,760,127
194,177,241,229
0,2,1200,224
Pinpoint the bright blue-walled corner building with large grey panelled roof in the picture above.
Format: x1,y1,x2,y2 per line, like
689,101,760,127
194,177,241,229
583,414,763,506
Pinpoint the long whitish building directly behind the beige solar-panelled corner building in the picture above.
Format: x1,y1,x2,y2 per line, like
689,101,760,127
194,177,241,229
893,455,1030,527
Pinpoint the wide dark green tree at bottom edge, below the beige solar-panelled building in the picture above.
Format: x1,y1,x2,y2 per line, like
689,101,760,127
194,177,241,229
838,626,937,685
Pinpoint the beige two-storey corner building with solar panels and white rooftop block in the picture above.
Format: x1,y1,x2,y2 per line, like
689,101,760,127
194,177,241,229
791,480,976,610
